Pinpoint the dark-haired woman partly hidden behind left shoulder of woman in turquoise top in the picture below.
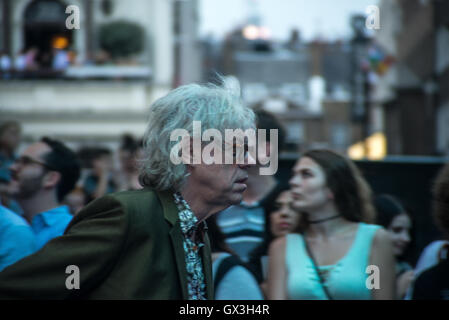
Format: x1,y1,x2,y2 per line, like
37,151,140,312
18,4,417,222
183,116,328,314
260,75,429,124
249,190,300,296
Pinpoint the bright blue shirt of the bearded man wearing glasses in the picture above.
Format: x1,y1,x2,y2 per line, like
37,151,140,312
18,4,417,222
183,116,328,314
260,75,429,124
31,206,73,249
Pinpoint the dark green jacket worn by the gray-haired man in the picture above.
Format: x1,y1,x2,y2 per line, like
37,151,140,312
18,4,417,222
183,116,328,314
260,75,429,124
0,189,213,300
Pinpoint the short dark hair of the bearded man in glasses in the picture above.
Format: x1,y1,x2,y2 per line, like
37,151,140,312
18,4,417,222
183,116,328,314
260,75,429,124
41,137,81,201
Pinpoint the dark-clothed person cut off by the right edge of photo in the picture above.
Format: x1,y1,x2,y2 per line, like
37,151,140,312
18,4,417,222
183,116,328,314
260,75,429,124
411,164,449,300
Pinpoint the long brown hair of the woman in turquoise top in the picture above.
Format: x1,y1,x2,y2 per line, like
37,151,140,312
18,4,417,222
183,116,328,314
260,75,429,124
302,149,375,223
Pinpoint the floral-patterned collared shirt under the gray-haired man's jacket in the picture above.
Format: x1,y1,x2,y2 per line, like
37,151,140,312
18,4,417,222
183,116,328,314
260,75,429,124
175,194,206,300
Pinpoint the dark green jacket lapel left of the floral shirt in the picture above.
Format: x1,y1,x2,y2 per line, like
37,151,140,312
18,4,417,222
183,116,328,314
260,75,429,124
157,191,189,299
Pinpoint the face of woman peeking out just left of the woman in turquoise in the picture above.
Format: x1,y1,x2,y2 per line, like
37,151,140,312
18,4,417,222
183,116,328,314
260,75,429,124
270,191,299,238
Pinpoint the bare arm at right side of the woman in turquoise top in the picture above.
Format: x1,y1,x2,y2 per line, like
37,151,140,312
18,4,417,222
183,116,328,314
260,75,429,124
370,229,396,300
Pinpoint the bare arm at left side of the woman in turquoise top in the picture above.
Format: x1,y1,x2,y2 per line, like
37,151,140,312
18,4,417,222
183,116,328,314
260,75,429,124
267,237,287,300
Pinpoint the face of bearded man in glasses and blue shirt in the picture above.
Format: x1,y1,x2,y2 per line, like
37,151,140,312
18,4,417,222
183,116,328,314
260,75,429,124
10,142,51,200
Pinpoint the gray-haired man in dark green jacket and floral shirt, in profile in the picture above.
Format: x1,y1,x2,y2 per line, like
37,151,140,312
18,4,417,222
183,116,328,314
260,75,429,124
0,81,254,300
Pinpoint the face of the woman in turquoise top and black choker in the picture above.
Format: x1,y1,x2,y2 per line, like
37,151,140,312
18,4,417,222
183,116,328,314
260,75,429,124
290,157,332,212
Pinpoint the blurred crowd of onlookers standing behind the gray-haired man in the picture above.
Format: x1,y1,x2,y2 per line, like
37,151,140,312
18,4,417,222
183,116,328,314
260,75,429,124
0,108,449,300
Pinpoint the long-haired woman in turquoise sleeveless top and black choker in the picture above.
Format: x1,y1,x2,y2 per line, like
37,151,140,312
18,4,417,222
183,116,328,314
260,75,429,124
268,150,395,300
